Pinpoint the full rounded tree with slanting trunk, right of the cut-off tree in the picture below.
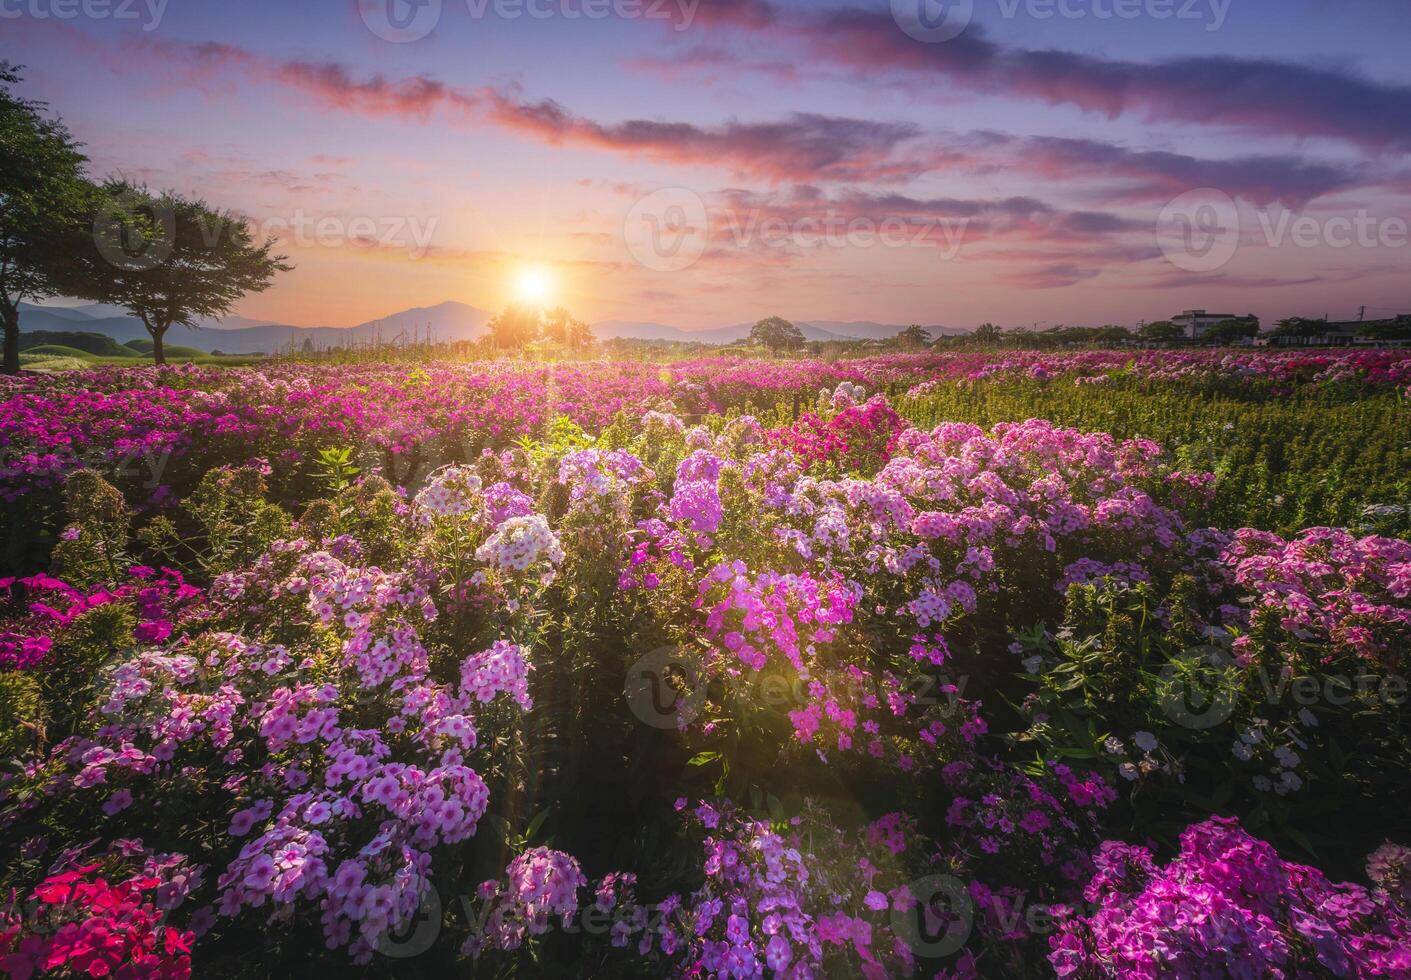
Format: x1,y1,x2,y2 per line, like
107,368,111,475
83,180,292,364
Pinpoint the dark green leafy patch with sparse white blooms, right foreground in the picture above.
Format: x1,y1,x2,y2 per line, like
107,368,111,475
1015,580,1411,862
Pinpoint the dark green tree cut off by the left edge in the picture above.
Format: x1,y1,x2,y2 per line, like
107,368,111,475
0,62,95,374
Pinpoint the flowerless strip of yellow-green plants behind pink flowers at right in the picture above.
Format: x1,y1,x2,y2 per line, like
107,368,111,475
897,375,1411,536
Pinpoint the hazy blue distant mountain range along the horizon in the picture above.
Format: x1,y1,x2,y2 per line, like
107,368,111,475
20,302,965,354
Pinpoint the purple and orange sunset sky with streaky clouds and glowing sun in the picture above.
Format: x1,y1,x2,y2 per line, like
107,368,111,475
0,0,1411,329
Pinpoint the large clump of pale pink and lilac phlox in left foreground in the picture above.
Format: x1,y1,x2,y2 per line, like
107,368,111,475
40,540,529,960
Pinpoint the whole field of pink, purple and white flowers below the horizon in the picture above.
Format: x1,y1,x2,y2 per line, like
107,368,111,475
0,351,1411,979
